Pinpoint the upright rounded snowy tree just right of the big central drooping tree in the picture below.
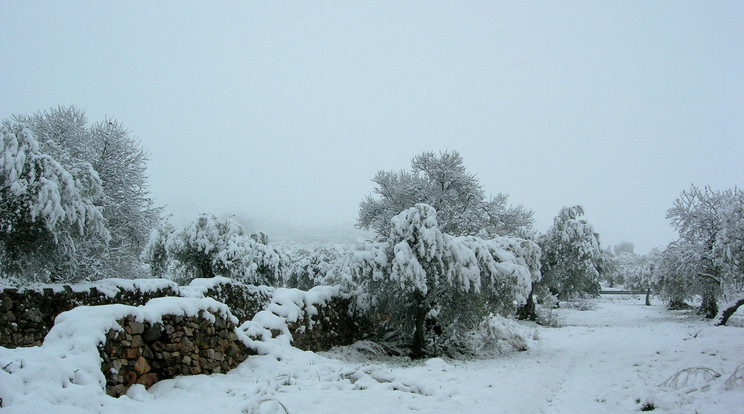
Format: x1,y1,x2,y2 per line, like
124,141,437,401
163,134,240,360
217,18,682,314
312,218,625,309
538,206,602,299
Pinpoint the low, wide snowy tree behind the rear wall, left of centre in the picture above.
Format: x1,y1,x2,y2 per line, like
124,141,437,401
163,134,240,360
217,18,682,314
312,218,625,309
142,214,289,285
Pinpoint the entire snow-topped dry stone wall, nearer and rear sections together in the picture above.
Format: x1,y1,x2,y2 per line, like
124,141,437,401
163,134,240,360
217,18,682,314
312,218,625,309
0,278,373,396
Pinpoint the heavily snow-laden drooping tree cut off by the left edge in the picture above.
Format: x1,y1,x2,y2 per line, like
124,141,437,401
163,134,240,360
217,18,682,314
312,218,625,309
0,124,110,281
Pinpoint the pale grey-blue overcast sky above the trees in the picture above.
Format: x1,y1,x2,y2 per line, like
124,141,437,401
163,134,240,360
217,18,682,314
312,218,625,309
0,0,744,253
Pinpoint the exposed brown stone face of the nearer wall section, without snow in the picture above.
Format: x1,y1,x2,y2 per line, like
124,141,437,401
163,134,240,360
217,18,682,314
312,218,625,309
99,311,255,397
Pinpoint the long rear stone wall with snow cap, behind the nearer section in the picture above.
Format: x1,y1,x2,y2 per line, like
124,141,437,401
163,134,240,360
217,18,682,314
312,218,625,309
0,277,371,350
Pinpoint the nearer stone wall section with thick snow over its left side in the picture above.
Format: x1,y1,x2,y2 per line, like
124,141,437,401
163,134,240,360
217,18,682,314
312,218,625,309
0,297,255,405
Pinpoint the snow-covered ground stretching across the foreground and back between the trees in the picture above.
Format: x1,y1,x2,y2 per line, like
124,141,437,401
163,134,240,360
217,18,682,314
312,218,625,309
0,296,744,414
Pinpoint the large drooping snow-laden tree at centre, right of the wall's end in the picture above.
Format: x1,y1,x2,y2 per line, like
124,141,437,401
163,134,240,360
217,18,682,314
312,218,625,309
346,204,539,356
